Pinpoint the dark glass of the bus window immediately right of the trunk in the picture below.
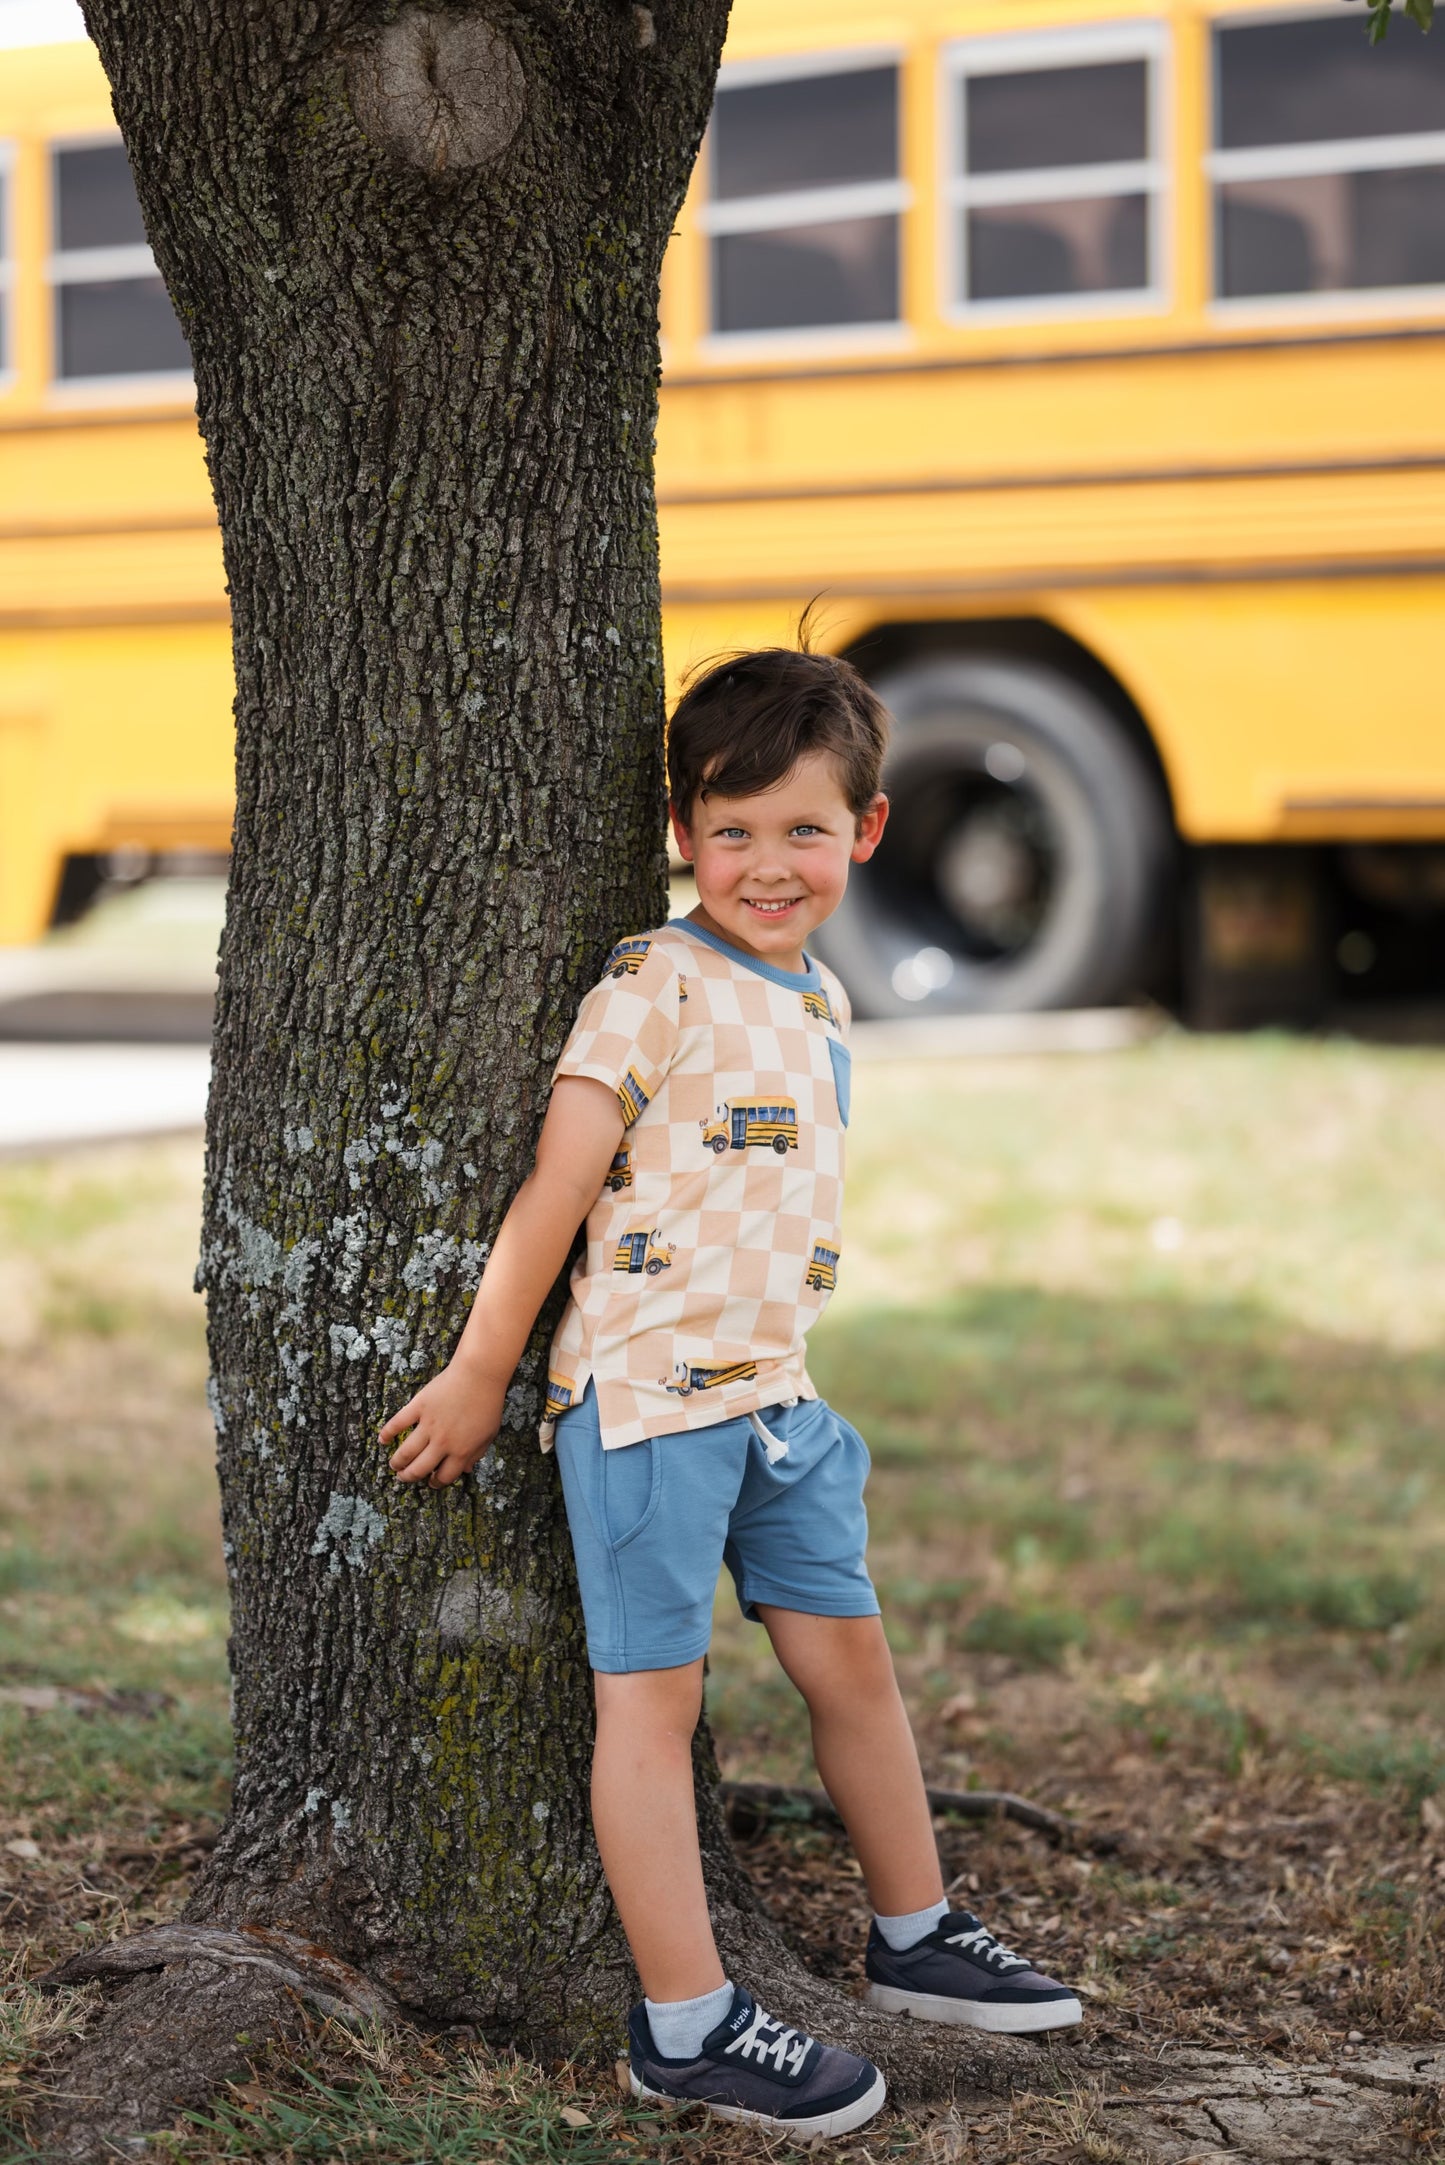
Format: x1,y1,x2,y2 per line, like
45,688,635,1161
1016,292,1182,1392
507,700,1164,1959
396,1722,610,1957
702,54,906,331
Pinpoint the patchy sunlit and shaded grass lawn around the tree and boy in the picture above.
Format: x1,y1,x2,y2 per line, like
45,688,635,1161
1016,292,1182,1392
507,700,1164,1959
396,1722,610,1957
0,1037,1445,2165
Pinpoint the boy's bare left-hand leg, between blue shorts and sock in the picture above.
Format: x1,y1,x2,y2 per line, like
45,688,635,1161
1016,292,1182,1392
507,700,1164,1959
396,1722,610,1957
591,1661,726,2000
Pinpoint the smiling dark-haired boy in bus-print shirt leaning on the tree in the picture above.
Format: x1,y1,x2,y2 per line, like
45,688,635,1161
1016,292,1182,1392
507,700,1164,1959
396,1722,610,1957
381,650,1081,2135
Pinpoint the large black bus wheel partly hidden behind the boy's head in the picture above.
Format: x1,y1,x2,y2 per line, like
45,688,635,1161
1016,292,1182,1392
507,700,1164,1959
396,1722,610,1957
810,654,1174,1018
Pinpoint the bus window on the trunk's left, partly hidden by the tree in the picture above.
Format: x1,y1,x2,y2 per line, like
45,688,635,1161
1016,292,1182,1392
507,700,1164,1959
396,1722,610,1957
50,143,191,383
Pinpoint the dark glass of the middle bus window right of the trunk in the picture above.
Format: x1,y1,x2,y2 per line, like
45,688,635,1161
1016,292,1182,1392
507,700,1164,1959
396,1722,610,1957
947,26,1163,314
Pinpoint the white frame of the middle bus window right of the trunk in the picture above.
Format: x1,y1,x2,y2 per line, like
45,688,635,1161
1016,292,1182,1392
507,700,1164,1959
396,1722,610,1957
938,15,1176,329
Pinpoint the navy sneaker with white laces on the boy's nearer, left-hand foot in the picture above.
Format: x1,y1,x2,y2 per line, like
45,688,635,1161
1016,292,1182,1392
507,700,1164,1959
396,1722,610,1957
628,1985,886,2135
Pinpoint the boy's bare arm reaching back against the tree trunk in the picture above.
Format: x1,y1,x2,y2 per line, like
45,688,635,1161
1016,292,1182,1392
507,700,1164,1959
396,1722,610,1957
381,1076,624,1487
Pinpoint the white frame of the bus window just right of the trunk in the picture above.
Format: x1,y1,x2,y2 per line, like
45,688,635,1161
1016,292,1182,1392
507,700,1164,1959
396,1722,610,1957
695,43,914,359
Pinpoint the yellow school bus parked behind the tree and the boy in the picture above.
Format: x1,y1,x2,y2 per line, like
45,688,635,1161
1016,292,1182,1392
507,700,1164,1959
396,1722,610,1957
0,0,1445,1015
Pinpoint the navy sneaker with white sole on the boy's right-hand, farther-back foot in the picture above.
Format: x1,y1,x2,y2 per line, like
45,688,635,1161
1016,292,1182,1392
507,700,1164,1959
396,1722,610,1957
864,1910,1083,2037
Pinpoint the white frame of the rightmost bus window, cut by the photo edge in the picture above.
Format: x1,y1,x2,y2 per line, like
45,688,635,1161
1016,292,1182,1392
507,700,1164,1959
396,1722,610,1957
1205,0,1445,327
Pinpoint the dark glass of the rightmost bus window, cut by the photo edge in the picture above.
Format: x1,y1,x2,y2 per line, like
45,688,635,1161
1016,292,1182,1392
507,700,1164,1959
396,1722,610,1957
1209,15,1445,301
